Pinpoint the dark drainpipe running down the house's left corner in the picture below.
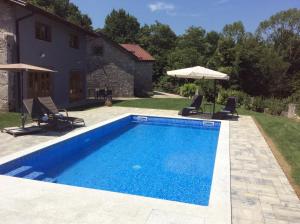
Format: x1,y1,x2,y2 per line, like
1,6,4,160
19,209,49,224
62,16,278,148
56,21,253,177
16,12,34,111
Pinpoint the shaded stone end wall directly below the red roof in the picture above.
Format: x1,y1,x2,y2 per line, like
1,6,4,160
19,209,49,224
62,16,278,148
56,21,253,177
134,61,153,96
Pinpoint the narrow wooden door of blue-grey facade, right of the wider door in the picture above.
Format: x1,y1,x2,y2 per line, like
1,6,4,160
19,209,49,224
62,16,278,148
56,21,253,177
69,72,83,102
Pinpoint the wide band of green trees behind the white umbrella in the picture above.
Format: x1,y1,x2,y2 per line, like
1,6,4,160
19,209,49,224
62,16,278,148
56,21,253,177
106,9,300,98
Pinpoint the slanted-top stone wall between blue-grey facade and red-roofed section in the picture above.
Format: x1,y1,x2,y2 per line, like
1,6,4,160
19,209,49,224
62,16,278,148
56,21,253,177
87,37,136,97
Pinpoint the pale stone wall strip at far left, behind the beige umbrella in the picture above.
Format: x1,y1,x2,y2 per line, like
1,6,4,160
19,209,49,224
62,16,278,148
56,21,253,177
0,0,16,111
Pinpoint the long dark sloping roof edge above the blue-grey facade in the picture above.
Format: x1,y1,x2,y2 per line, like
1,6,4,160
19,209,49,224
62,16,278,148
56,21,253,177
7,0,145,61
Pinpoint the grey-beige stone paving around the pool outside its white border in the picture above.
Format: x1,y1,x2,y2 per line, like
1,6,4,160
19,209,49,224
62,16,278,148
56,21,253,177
0,107,300,224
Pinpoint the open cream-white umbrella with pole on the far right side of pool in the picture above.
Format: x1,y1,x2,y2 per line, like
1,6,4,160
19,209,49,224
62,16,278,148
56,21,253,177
167,66,229,114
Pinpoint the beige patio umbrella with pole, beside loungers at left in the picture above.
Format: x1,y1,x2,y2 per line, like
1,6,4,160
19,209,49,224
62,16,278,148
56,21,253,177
0,63,57,135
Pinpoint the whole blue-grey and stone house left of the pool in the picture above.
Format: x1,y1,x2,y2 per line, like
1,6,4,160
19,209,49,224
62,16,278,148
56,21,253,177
0,0,154,111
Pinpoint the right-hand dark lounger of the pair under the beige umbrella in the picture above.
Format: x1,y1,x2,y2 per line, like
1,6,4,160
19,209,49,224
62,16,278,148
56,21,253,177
38,96,85,128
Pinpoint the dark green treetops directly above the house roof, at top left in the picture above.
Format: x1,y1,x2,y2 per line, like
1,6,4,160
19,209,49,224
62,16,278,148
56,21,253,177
28,0,92,29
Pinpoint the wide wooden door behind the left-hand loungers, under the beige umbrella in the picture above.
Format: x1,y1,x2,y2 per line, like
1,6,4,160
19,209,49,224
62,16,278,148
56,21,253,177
27,72,52,98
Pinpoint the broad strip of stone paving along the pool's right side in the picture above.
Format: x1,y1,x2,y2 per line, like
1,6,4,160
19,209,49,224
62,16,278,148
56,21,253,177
230,116,300,224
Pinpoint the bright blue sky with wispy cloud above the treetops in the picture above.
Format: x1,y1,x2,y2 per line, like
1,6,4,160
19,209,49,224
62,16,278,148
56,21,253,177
71,0,300,34
